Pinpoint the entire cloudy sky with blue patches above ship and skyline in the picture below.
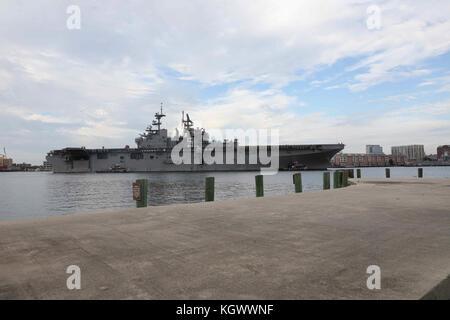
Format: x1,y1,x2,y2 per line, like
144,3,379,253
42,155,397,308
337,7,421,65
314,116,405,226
0,0,450,164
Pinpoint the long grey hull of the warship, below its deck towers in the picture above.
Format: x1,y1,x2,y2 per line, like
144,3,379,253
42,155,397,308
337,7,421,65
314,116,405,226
47,144,344,173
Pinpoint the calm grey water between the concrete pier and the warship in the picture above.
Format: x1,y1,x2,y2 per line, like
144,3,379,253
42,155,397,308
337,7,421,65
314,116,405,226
0,167,450,221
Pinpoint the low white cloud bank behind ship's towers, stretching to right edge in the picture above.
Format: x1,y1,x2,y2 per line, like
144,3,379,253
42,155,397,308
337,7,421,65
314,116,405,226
185,90,450,153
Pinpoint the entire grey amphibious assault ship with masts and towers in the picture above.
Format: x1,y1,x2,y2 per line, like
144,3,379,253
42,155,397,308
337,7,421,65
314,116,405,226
47,106,344,173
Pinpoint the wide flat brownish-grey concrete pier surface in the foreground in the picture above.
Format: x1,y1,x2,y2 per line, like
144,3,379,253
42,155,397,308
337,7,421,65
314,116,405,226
0,179,450,299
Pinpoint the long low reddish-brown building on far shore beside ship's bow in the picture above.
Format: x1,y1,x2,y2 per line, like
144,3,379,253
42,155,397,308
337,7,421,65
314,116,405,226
332,153,405,168
